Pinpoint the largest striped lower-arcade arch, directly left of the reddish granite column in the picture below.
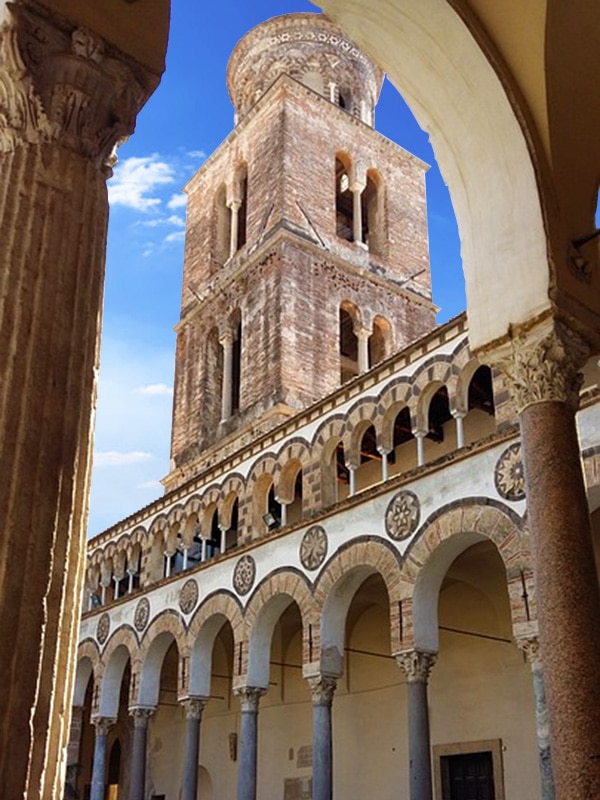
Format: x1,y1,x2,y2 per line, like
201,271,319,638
401,498,536,652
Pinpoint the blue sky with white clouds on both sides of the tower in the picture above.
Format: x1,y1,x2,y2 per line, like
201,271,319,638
89,0,465,536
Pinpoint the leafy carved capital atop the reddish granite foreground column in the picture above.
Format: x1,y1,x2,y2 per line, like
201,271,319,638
485,318,590,414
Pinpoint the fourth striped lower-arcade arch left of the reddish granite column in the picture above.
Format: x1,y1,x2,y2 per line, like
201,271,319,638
187,592,246,697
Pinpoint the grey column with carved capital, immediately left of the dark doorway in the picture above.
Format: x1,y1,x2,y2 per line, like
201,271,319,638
396,650,437,800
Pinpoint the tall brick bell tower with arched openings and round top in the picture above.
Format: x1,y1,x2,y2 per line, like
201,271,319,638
164,13,435,489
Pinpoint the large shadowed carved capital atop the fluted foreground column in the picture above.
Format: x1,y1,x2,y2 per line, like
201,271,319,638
0,0,158,170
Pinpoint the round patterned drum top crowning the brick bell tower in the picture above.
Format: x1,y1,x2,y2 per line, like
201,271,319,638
227,12,383,125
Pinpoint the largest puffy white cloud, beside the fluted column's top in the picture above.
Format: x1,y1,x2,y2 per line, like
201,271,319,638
108,153,175,212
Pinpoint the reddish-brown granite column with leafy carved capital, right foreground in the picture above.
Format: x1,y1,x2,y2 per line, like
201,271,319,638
486,319,600,800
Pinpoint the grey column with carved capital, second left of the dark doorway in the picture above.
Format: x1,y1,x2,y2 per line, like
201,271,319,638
307,675,337,800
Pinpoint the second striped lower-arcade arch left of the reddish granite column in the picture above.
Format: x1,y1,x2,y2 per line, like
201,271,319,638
313,537,401,675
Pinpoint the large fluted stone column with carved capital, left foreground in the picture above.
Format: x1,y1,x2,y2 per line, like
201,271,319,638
0,6,162,800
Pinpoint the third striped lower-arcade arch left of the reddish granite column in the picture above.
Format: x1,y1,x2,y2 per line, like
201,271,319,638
245,570,318,688
